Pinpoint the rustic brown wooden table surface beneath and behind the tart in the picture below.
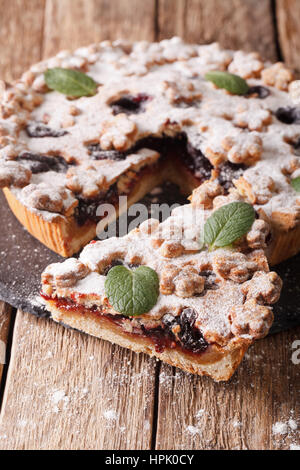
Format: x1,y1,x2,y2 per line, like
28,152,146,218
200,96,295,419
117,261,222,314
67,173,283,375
0,0,300,450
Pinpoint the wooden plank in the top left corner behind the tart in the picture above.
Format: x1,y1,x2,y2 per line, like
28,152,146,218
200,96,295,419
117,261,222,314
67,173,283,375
0,0,45,81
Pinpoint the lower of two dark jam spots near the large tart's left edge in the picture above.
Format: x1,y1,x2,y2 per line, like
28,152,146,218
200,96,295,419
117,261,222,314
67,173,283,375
17,152,69,174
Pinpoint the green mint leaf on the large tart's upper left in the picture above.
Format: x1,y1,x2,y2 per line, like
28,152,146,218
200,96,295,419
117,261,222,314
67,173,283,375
44,67,97,97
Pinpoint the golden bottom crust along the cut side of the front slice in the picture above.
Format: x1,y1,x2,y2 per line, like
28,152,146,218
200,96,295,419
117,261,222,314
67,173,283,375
44,300,250,382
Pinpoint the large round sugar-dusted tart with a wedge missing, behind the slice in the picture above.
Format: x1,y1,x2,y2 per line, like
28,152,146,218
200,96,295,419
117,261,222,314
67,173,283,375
0,38,300,264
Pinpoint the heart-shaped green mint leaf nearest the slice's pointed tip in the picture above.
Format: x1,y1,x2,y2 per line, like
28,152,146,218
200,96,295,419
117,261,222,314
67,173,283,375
105,266,159,315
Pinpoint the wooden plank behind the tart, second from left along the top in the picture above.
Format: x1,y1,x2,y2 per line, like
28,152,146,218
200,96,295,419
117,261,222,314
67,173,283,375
44,0,155,56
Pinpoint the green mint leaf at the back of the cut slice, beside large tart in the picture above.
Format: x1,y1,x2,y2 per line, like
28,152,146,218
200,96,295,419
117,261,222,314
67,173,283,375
204,202,255,248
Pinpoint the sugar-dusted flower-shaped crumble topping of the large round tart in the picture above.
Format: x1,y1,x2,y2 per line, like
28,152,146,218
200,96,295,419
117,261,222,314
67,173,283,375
0,38,300,230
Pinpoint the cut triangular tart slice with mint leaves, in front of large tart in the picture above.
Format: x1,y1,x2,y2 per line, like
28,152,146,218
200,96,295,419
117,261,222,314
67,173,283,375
41,195,282,381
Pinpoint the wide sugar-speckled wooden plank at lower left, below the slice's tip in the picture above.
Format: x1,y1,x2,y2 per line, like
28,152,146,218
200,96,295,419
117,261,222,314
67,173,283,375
0,312,156,450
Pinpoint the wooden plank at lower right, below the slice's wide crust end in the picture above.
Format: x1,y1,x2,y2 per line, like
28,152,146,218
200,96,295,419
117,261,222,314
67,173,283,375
156,329,300,450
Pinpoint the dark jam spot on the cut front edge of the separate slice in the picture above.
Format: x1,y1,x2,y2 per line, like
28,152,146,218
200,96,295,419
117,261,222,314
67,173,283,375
162,308,208,353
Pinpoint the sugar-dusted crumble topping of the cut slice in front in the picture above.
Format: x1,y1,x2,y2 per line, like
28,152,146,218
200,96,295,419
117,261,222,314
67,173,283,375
42,204,281,346
